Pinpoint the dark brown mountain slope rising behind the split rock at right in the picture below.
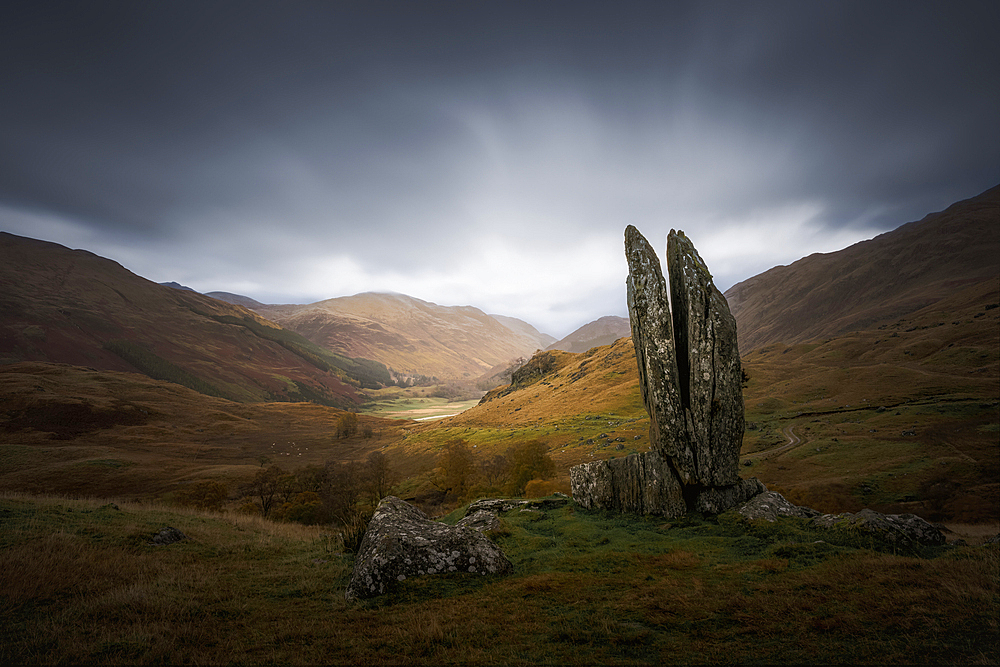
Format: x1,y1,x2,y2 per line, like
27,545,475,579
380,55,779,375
725,186,1000,353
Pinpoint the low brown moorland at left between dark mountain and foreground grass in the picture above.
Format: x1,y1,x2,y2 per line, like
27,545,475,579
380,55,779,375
0,362,403,499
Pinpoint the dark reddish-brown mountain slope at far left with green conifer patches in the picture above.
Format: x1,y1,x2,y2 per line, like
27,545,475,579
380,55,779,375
0,233,388,406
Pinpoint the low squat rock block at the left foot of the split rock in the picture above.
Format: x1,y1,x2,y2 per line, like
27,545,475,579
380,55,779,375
569,452,687,518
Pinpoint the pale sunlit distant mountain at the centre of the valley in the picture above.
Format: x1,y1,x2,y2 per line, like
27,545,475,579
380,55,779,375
254,292,539,381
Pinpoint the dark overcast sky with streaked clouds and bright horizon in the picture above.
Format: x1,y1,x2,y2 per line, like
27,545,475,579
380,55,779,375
0,0,1000,337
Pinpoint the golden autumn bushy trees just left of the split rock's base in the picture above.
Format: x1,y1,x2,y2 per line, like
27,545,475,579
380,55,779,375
432,440,556,501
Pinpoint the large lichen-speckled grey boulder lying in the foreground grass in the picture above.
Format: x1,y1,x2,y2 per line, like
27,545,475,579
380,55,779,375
346,496,513,600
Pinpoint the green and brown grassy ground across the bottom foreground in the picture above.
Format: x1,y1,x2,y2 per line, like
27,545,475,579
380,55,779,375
0,495,1000,664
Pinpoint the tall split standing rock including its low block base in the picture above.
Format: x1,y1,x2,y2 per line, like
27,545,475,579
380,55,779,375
571,225,763,516
